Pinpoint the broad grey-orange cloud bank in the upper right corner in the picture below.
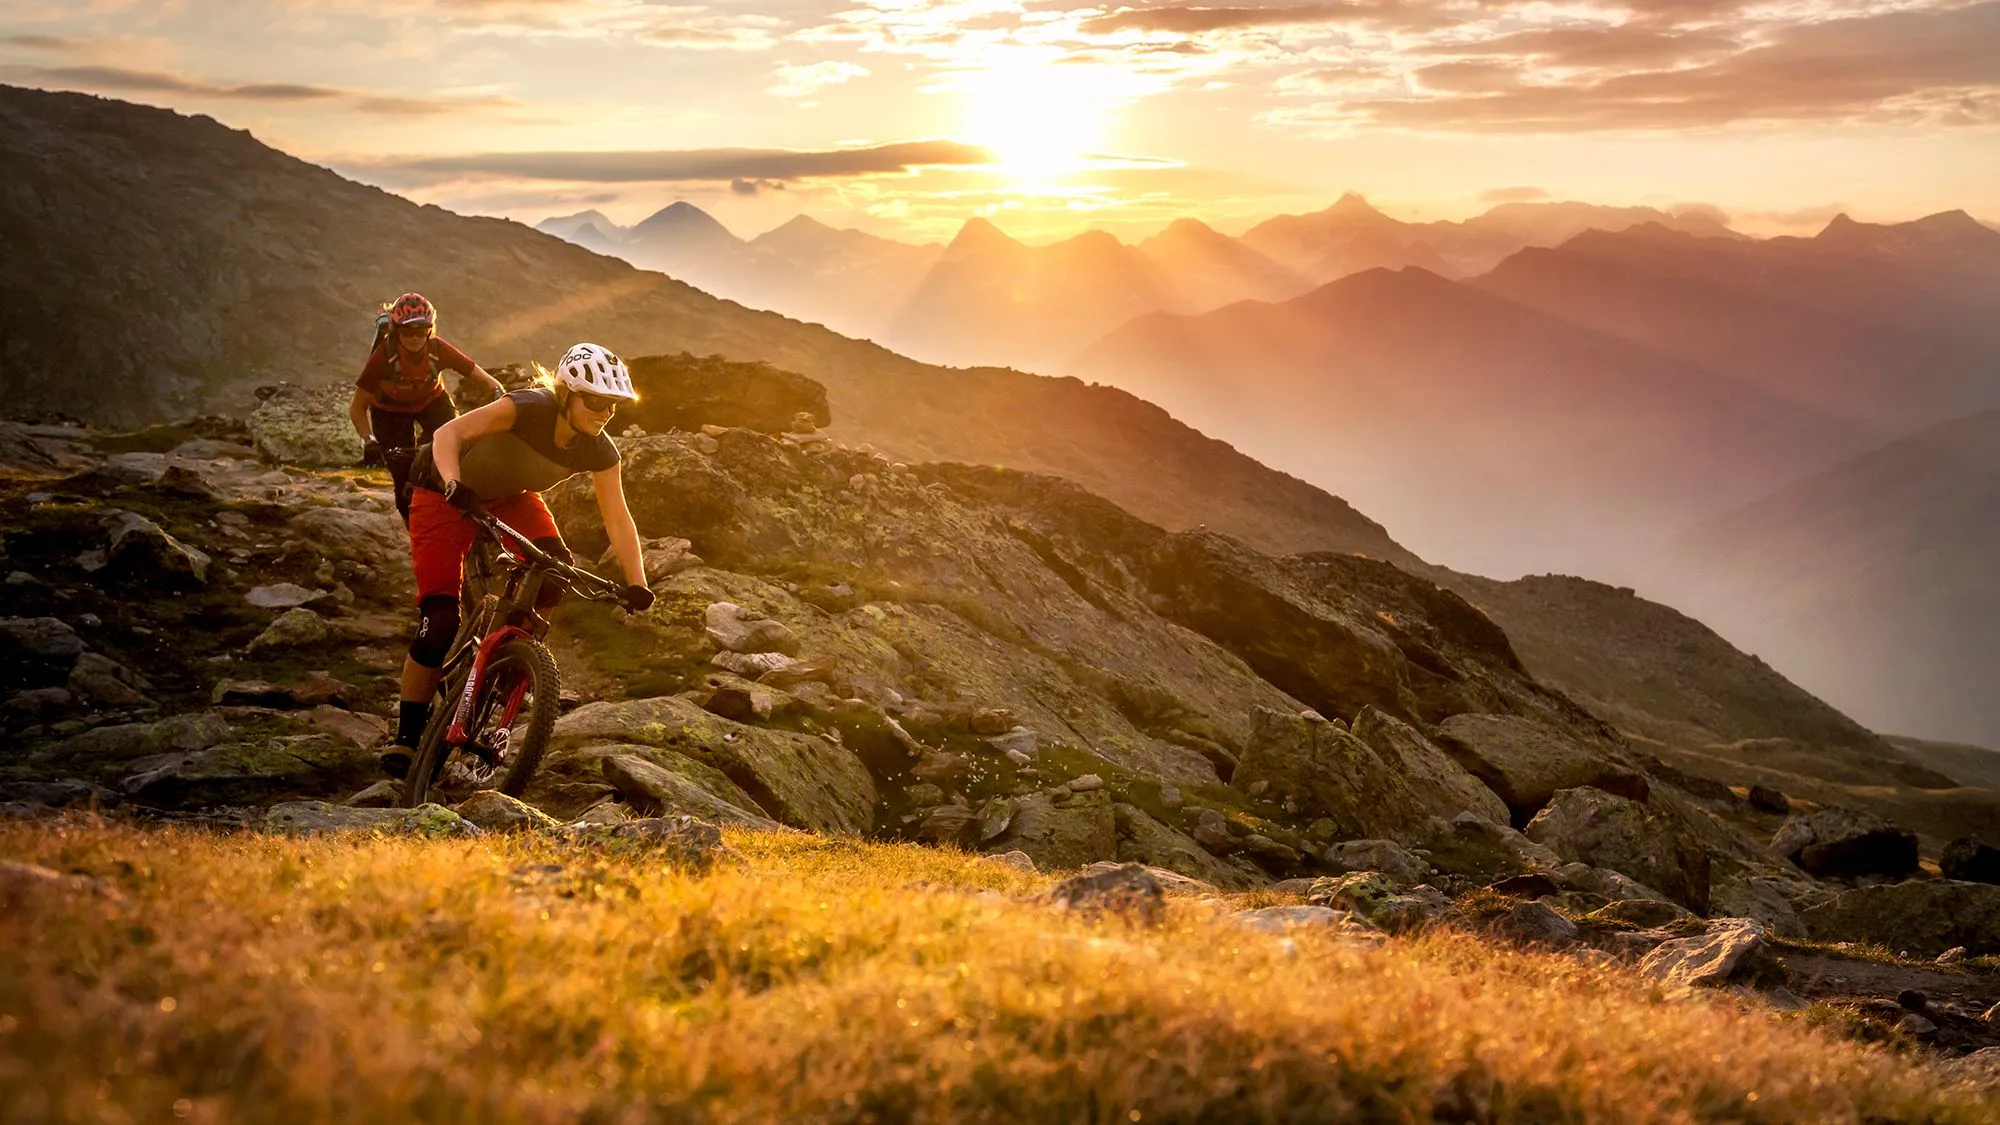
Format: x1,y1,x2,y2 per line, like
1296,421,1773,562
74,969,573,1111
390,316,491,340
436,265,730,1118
1296,0,2000,132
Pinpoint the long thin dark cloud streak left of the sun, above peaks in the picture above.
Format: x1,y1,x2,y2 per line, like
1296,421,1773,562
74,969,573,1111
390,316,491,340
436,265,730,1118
362,140,994,184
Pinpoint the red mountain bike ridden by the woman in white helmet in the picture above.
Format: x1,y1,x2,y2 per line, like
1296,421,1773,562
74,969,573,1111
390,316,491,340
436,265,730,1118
402,510,622,809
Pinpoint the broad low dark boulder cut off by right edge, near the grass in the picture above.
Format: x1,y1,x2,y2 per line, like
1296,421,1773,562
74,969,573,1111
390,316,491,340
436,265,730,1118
1800,879,2000,957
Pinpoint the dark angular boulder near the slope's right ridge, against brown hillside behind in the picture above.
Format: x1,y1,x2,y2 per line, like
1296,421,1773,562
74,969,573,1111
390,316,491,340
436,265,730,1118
1436,715,1648,825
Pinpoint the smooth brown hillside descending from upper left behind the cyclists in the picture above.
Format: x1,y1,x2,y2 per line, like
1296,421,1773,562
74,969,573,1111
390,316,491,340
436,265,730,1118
0,88,1404,558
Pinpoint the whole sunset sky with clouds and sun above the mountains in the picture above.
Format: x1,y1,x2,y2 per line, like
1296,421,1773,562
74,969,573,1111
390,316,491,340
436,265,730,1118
0,0,2000,238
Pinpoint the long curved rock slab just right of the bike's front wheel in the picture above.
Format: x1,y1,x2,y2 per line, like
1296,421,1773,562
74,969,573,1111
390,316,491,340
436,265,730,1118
554,697,872,832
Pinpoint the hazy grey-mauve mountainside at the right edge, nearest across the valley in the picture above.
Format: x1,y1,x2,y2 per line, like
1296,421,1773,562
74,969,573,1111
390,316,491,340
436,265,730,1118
1650,410,2000,745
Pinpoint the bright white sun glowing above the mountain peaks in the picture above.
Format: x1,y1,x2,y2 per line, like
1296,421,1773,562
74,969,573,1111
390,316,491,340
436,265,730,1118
964,58,1114,184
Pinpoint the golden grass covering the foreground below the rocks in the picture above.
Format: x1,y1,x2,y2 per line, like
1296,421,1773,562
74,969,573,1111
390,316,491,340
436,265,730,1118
0,823,1992,1125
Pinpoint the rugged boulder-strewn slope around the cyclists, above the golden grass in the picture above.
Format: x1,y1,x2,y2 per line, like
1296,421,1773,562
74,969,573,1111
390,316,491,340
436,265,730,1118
11,410,2000,1051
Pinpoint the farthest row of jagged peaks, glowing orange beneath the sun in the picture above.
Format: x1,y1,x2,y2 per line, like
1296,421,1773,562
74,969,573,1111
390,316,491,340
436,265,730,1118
536,194,1740,372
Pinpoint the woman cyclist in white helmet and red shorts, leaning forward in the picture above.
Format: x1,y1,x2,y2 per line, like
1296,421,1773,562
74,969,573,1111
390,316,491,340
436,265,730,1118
382,344,652,777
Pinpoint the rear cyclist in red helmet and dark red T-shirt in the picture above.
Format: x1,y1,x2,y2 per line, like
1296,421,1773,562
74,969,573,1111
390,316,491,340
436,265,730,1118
348,292,502,522
